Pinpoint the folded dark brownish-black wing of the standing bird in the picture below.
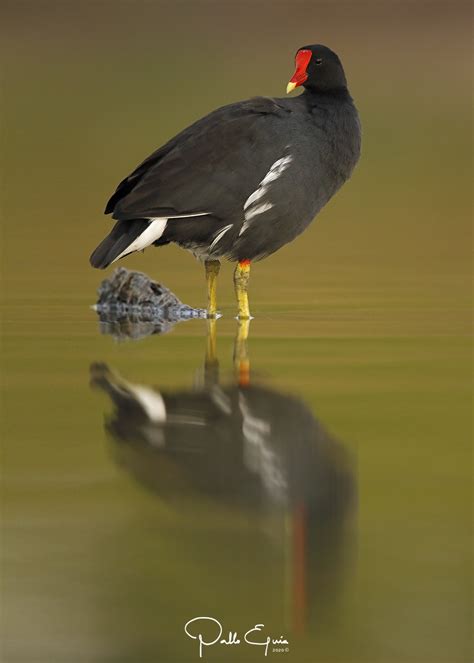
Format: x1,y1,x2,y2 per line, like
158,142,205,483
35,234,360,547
106,97,290,220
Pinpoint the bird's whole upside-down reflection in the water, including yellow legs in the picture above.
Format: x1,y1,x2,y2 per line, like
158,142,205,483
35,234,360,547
91,320,356,631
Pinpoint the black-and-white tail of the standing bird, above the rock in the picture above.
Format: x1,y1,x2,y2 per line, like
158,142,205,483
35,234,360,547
90,219,163,269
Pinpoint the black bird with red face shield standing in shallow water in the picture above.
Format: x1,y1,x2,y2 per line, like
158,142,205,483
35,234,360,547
90,44,361,319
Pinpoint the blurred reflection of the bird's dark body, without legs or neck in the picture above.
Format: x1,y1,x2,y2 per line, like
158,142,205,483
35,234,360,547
91,363,355,520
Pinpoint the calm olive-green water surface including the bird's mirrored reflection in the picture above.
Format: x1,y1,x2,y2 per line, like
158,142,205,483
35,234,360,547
2,286,469,663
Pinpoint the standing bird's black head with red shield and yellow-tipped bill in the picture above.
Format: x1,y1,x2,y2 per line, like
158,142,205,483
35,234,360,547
286,44,347,94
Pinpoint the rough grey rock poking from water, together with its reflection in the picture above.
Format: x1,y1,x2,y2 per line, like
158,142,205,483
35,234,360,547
94,267,206,339
